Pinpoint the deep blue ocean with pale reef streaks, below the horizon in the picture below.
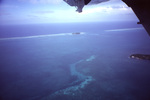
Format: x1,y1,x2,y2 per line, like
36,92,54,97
0,22,150,100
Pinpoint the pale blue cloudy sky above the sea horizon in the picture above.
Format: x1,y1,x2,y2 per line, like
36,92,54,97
0,0,138,25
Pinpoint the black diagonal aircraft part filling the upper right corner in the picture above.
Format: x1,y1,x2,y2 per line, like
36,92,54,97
122,0,150,35
